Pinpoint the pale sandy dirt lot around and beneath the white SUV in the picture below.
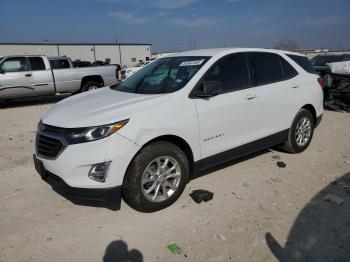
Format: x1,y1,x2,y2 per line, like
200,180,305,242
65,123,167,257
0,96,350,261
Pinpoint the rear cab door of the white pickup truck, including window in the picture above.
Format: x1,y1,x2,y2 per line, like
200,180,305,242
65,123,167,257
28,56,55,95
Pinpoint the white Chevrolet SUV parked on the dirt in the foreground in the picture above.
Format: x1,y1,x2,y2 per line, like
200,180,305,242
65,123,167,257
34,48,323,212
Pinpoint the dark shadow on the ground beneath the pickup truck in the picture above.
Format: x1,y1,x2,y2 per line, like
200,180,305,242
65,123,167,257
0,94,71,109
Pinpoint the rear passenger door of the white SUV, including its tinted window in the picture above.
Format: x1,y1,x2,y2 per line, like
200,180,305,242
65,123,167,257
247,52,300,137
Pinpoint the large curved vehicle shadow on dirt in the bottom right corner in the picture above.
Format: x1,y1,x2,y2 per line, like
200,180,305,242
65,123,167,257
265,172,350,262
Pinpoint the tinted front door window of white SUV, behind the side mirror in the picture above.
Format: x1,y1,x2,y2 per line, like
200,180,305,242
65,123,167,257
204,54,249,92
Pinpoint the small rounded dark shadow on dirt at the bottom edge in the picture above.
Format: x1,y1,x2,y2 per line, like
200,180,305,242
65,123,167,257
103,240,143,262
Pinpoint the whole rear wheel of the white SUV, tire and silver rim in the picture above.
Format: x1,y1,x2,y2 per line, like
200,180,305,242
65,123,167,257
283,109,315,154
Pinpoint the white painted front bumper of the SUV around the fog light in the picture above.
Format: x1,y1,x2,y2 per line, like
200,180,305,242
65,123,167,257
35,134,140,189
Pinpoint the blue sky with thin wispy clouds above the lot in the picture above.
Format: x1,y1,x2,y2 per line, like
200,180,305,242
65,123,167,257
0,0,350,52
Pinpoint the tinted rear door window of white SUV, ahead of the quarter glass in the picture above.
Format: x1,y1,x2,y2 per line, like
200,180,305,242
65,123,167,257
247,53,284,86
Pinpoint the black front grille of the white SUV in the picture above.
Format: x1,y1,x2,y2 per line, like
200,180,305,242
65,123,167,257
36,134,63,158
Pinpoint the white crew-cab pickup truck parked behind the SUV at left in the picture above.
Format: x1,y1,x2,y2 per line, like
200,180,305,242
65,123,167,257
0,55,118,100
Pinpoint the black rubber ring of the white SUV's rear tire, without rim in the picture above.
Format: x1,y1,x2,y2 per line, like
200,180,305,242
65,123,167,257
288,109,315,153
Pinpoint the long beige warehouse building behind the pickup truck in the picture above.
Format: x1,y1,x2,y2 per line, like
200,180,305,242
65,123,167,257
0,43,152,66
